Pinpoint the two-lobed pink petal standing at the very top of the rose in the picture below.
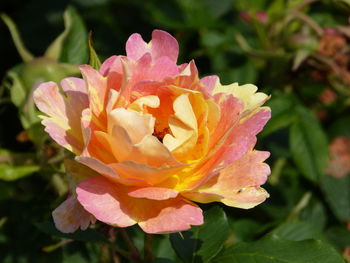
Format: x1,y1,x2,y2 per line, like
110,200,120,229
126,30,179,62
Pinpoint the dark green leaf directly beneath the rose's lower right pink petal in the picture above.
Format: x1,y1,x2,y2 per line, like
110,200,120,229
170,207,229,263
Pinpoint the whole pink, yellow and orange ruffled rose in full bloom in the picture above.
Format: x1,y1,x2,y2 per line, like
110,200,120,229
34,30,270,233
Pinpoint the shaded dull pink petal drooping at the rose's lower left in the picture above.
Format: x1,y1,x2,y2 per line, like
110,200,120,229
52,197,96,233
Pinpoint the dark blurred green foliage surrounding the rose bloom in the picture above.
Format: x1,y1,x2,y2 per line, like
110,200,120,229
0,0,350,263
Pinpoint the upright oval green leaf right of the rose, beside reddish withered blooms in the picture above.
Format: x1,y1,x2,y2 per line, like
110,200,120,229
289,106,328,182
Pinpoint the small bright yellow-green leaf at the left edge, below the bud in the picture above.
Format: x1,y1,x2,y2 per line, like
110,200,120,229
0,164,40,181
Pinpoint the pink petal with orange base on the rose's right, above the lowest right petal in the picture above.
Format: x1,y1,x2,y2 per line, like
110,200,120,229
177,104,270,190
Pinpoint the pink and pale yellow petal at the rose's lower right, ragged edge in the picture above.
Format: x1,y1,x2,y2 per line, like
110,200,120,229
183,151,270,208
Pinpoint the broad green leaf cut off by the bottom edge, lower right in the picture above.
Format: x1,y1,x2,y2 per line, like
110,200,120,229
211,238,344,263
